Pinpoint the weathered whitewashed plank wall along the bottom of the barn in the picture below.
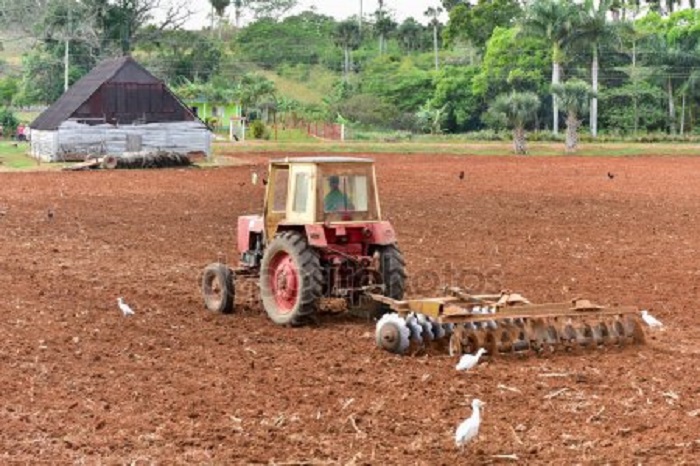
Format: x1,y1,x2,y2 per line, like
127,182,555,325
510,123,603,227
31,121,212,162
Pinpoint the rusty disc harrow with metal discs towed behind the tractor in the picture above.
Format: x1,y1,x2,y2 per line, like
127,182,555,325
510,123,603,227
371,288,644,356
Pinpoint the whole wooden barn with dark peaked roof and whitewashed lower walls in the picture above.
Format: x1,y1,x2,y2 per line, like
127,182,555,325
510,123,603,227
29,56,213,162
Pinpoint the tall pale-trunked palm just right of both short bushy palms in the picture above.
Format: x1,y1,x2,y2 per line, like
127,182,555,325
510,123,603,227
573,0,620,137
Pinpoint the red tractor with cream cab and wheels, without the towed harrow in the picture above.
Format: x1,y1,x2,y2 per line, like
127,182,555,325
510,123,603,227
202,157,406,325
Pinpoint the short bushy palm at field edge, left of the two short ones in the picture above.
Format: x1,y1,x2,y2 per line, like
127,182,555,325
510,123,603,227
489,92,540,155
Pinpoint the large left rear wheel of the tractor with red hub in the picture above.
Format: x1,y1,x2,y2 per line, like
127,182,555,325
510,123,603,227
260,231,323,325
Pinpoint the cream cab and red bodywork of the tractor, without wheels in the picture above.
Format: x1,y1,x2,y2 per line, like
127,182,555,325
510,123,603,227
238,157,396,268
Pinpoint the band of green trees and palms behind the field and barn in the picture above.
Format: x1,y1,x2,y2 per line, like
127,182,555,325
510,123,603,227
0,0,700,147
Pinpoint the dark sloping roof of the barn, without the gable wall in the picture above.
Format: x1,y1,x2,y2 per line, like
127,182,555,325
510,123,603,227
29,56,196,131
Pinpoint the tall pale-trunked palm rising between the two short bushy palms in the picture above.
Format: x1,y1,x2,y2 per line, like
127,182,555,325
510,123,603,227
522,0,579,134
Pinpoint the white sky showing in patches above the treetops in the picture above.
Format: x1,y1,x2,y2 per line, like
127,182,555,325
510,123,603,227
188,0,446,28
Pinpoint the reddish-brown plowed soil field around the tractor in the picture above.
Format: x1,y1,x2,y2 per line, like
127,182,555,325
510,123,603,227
0,155,700,465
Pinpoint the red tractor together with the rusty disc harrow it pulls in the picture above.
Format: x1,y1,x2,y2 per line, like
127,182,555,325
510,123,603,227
202,157,644,355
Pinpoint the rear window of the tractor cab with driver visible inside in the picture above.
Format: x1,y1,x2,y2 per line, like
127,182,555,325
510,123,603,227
321,167,376,221
